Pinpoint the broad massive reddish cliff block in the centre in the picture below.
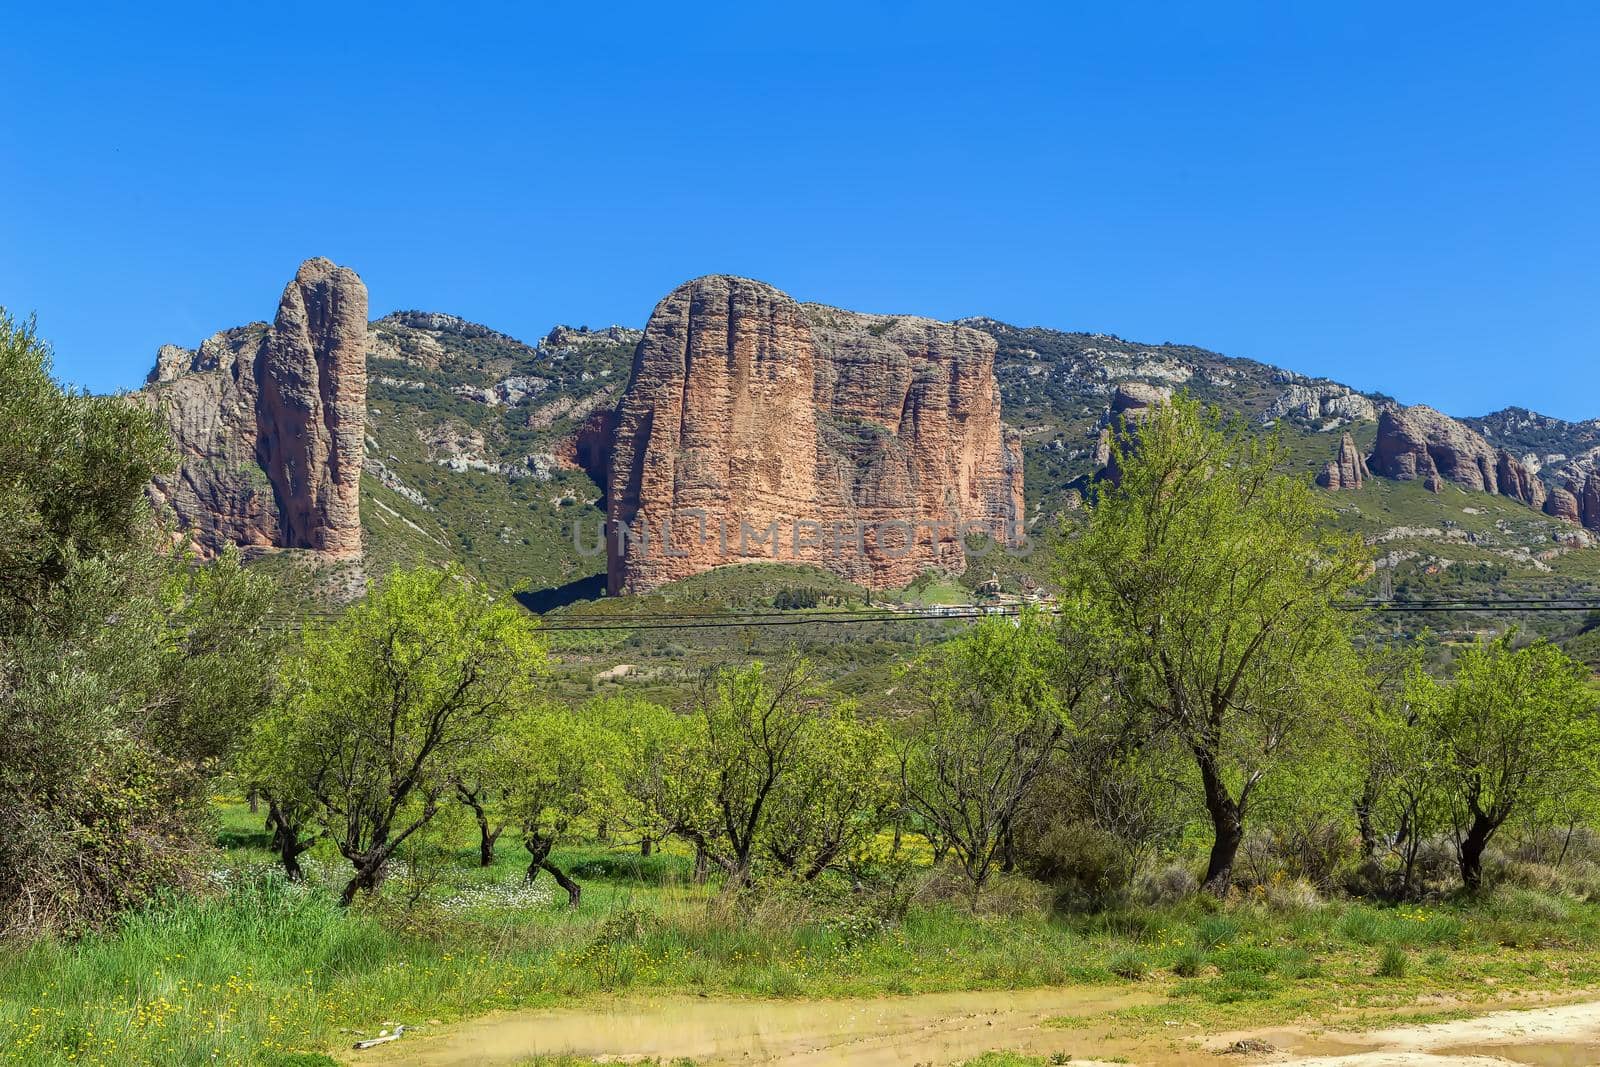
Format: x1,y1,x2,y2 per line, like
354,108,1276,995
606,275,1022,592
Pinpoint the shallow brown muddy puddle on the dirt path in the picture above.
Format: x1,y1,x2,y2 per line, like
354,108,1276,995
349,989,1158,1067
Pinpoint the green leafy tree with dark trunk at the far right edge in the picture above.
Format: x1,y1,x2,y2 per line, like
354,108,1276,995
1408,635,1600,893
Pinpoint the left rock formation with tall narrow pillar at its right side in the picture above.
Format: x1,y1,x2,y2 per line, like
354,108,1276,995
144,259,366,560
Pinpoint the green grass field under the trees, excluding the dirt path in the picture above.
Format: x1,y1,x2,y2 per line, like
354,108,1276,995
0,801,1600,1065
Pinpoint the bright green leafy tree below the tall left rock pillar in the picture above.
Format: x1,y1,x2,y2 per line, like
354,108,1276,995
262,566,544,904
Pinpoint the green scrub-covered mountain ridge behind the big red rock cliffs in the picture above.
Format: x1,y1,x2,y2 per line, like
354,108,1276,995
131,259,1600,614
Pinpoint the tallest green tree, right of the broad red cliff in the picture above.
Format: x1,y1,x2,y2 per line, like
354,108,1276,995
1059,397,1368,893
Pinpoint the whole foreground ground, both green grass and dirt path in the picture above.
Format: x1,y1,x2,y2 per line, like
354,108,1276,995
0,798,1600,1067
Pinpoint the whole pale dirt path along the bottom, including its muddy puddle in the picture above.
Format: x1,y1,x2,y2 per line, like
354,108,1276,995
346,987,1600,1067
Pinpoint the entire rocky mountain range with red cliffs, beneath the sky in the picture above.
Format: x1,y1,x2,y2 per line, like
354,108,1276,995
139,261,1600,614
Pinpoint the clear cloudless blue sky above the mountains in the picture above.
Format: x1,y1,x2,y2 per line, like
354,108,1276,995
0,0,1600,418
